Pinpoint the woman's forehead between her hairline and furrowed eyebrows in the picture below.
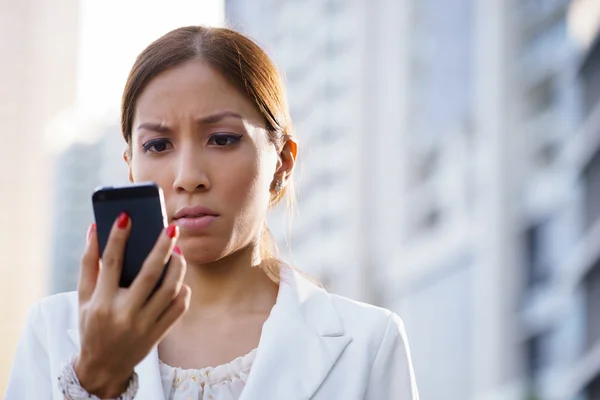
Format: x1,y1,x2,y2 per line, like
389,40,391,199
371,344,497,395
134,60,264,126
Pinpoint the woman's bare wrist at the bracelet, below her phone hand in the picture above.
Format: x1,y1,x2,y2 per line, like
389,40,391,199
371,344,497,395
73,357,133,399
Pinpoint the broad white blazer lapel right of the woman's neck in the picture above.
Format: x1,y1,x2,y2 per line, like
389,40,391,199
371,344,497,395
240,268,352,400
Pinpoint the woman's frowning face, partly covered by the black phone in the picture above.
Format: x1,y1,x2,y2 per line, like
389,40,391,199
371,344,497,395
126,60,281,263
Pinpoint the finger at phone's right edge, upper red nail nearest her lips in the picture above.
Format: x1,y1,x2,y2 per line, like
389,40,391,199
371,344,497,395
129,225,179,310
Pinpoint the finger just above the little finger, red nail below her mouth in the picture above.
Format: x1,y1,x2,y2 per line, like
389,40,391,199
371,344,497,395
142,253,187,326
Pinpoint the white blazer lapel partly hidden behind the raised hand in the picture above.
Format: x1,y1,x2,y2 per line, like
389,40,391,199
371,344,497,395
67,329,165,400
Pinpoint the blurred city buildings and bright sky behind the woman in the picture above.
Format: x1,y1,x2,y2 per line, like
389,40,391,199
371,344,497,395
0,0,600,400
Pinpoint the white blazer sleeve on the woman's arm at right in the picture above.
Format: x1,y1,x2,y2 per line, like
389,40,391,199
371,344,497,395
365,313,419,400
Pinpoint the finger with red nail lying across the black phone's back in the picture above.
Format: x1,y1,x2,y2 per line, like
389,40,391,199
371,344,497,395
98,213,131,295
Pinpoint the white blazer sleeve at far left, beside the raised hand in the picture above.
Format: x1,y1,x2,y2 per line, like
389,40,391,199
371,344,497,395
5,303,53,400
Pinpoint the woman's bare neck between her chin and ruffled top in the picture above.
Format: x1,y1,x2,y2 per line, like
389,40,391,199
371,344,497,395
185,246,278,318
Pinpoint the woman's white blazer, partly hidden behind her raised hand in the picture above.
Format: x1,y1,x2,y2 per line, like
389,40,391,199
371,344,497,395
5,269,419,400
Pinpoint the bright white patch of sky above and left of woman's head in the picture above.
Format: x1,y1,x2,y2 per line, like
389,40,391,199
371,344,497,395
75,0,225,120
